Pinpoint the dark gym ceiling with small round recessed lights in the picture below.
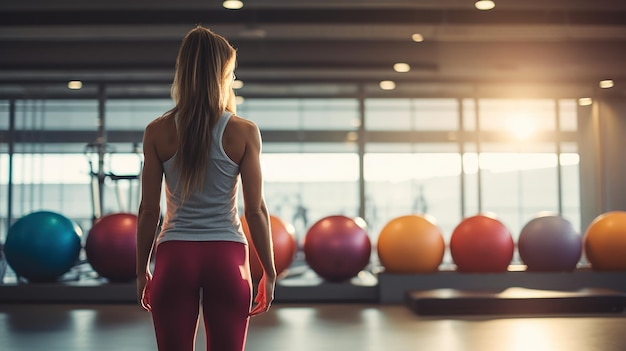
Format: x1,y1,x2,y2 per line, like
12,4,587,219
0,0,626,97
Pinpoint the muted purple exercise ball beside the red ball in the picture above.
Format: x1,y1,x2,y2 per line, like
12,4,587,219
517,214,582,272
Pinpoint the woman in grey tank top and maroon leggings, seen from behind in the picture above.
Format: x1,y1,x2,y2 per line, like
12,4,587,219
137,26,276,351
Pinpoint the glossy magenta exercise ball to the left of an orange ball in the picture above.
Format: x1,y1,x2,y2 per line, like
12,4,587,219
303,215,372,282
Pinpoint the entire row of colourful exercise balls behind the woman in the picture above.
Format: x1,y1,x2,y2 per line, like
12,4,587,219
5,211,626,281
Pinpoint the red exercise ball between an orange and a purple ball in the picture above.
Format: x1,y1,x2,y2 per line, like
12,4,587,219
450,215,515,273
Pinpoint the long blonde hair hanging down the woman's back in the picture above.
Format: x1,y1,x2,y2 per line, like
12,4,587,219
170,26,236,201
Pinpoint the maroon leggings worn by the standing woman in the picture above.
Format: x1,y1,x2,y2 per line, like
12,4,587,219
150,241,252,351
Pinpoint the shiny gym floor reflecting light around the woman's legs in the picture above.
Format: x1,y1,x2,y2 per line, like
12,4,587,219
0,303,626,351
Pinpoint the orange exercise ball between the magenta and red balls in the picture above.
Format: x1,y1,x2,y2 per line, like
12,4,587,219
376,215,446,274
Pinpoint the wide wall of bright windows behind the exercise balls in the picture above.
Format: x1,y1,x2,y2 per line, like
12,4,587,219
0,98,581,258
